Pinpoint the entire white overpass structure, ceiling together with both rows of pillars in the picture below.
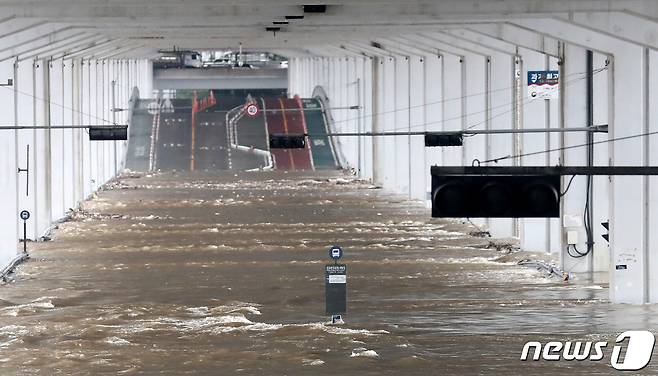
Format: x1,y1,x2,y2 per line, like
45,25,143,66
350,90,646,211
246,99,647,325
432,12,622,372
0,0,658,304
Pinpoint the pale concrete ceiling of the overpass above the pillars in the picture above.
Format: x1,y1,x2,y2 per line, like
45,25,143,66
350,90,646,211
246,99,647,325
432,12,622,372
0,0,658,59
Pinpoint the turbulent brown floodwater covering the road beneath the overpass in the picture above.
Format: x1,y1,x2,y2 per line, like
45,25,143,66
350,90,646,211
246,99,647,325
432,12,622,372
0,172,658,376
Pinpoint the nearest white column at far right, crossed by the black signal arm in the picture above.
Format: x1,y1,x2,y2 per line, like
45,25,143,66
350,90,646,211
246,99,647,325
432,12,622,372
609,44,658,304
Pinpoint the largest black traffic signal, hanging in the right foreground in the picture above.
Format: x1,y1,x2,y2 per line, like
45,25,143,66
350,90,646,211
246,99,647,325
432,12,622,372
432,174,560,218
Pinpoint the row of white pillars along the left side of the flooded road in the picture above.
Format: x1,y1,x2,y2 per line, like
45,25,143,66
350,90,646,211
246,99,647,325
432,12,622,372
0,59,152,266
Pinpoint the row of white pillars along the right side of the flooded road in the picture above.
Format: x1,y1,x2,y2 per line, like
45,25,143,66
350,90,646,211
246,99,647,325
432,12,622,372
289,31,658,303
